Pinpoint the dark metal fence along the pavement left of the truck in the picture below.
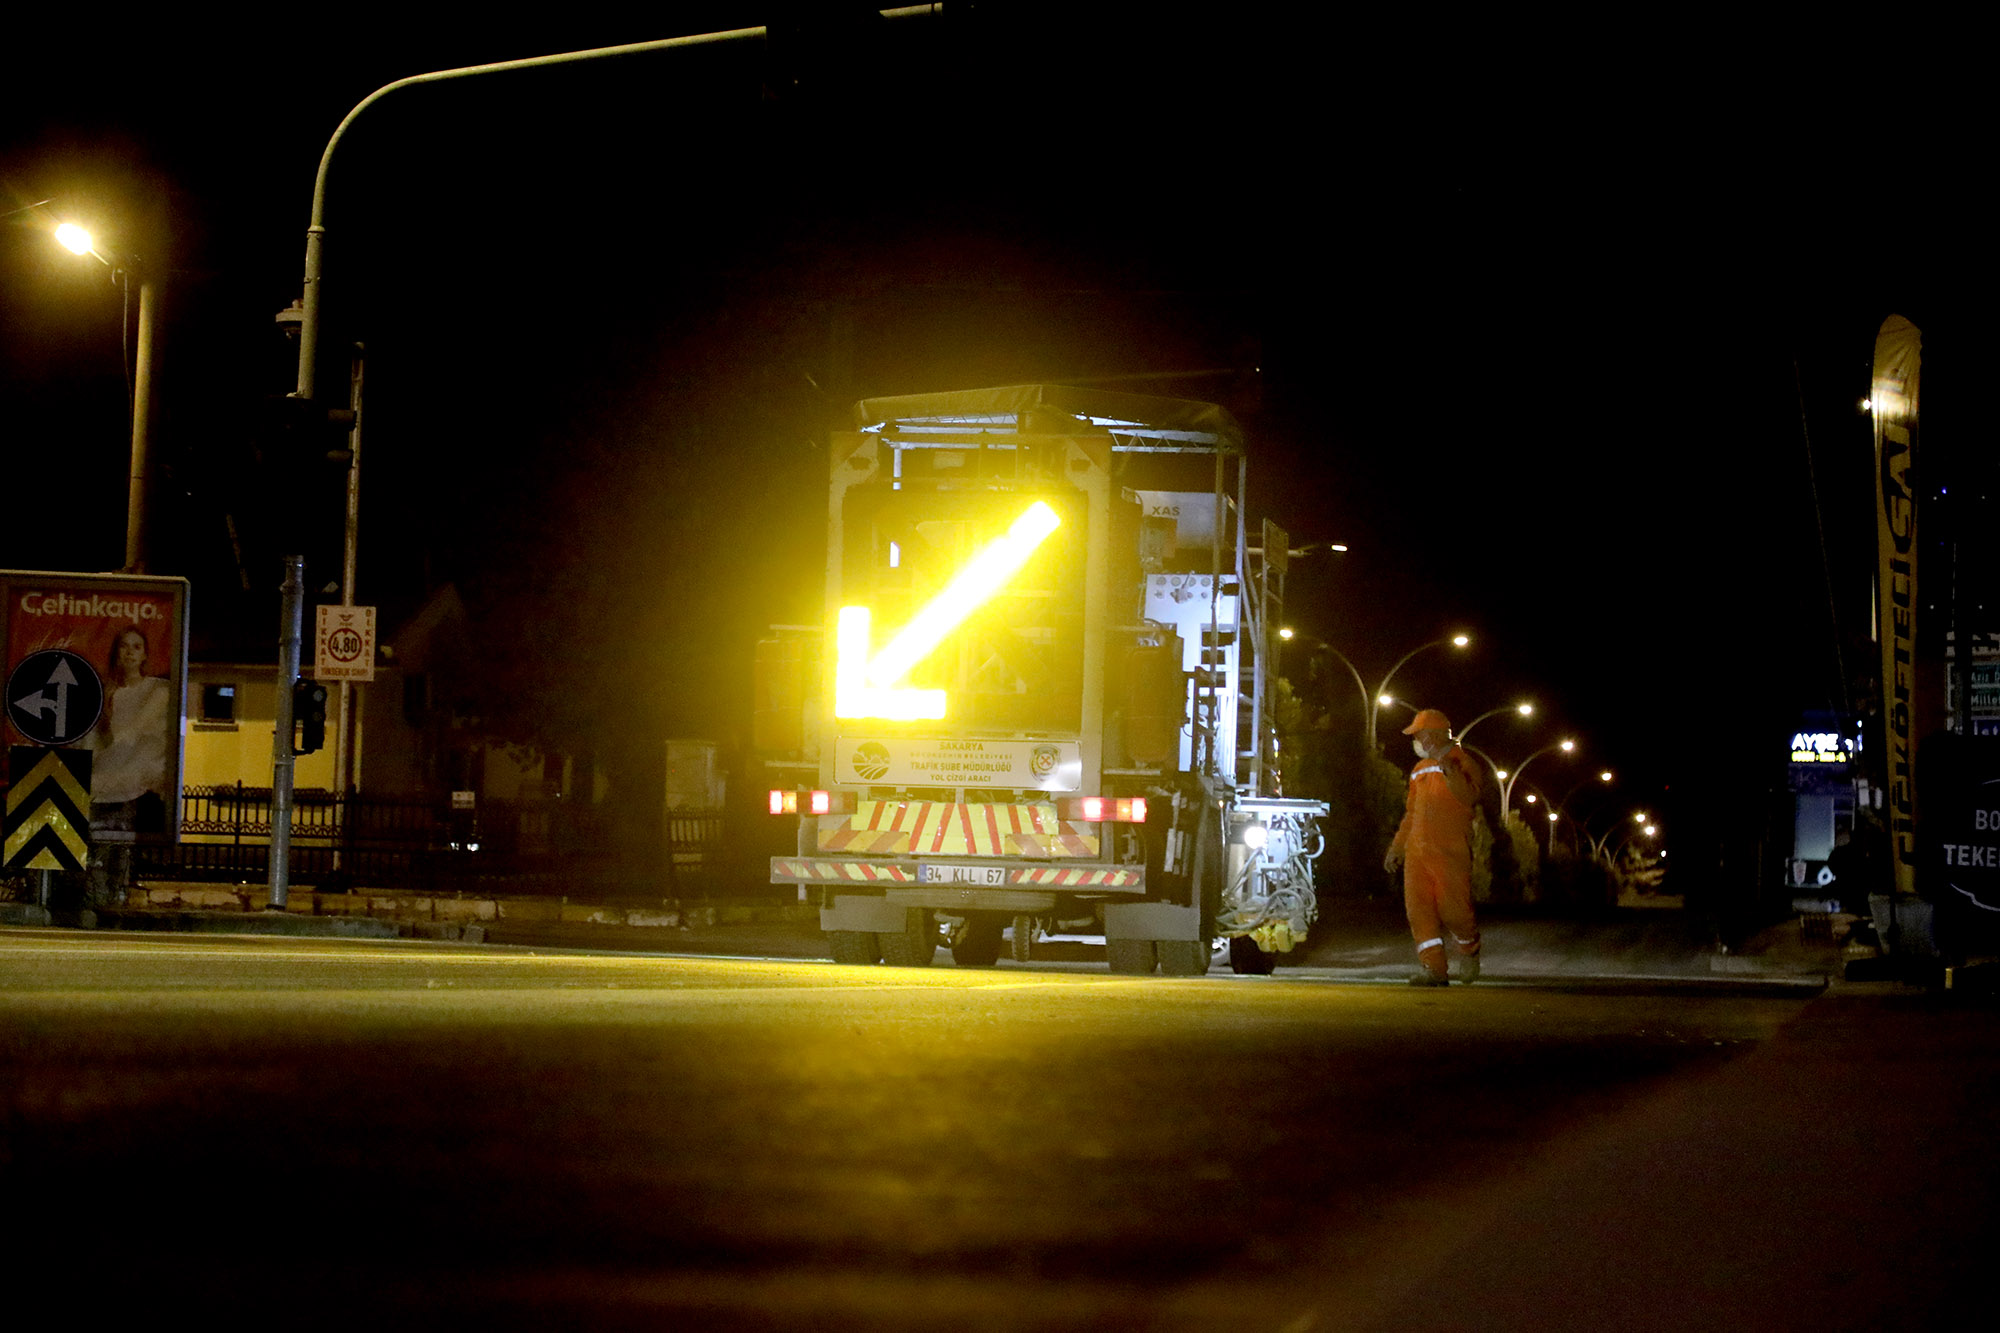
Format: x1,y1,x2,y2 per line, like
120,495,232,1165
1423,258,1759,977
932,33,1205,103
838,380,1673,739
134,783,724,893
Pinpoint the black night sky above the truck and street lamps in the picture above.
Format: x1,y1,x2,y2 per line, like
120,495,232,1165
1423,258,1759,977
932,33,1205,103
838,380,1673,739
0,4,1986,852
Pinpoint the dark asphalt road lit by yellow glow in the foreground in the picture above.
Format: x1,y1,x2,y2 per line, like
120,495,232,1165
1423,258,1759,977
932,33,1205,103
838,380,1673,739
0,931,1984,1333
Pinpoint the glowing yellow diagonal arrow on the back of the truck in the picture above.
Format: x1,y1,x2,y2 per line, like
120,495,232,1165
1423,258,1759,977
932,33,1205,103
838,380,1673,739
834,500,1062,721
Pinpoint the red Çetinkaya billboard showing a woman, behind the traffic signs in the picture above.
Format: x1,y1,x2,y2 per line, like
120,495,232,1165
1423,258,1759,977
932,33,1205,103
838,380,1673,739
0,570,188,843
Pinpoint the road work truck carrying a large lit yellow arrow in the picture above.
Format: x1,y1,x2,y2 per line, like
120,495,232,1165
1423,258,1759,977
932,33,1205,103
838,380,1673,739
754,384,1326,975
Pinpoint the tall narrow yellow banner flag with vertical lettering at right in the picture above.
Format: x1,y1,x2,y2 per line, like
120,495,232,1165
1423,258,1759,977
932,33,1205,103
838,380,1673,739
1868,314,1922,895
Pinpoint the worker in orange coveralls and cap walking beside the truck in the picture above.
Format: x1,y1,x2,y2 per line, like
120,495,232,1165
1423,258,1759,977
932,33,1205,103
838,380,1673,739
1382,709,1480,987
